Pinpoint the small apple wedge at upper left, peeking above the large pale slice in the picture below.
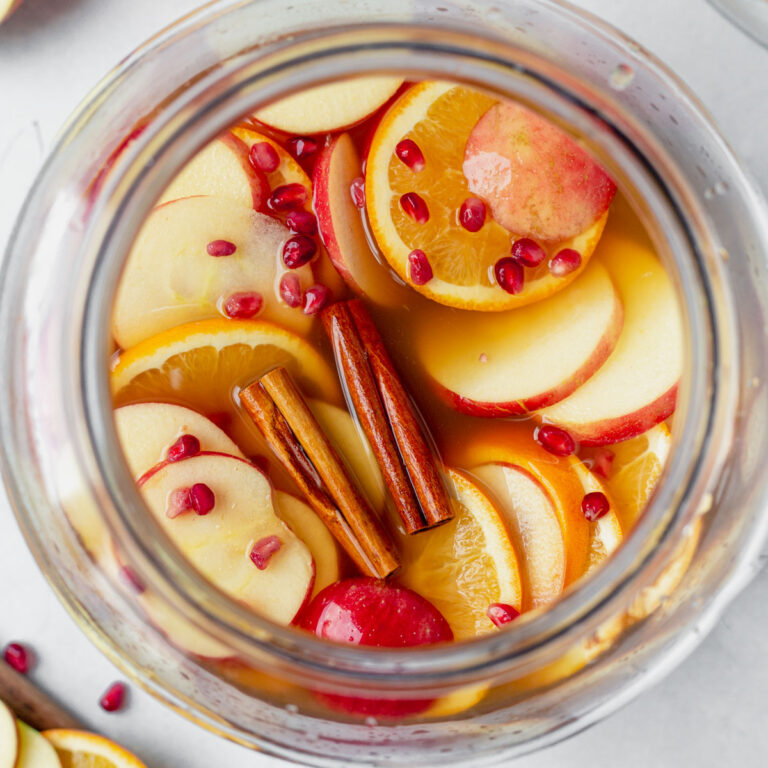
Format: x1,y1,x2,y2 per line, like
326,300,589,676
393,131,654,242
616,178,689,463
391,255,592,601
158,131,269,210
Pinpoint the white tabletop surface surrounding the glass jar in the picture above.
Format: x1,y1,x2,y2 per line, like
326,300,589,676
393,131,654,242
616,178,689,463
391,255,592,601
0,0,768,768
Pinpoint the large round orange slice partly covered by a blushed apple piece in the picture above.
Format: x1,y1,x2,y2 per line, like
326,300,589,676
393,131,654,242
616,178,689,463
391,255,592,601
365,82,607,311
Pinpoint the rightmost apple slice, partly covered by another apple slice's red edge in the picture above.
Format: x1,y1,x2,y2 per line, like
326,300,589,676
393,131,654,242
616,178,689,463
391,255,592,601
539,232,685,445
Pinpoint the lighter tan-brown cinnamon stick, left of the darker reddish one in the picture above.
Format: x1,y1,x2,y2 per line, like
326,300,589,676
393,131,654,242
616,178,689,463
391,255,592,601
240,368,400,578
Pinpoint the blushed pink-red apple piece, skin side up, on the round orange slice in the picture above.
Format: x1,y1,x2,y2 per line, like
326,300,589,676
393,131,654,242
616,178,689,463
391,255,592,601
464,101,616,243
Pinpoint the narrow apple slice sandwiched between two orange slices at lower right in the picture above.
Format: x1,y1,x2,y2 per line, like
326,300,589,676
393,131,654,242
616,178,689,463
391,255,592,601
472,462,567,610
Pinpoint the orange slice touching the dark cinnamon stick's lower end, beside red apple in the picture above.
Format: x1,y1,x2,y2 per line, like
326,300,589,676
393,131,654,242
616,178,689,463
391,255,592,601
398,470,522,640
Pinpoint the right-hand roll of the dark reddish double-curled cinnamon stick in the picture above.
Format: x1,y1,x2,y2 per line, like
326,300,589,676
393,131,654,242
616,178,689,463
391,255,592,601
347,299,453,528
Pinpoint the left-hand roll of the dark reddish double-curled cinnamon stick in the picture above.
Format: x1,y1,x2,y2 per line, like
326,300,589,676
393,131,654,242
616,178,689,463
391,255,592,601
320,302,425,534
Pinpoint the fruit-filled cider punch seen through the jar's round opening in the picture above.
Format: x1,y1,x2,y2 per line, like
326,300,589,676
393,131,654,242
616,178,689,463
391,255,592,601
110,75,684,716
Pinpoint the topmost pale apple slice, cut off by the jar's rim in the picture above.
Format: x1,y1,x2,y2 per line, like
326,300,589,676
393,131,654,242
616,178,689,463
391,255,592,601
254,75,403,134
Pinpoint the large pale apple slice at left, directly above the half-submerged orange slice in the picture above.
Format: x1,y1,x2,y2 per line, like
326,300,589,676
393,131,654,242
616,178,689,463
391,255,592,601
112,196,314,349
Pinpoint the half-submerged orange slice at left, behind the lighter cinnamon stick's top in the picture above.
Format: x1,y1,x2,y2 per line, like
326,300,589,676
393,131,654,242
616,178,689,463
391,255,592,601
111,318,340,462
